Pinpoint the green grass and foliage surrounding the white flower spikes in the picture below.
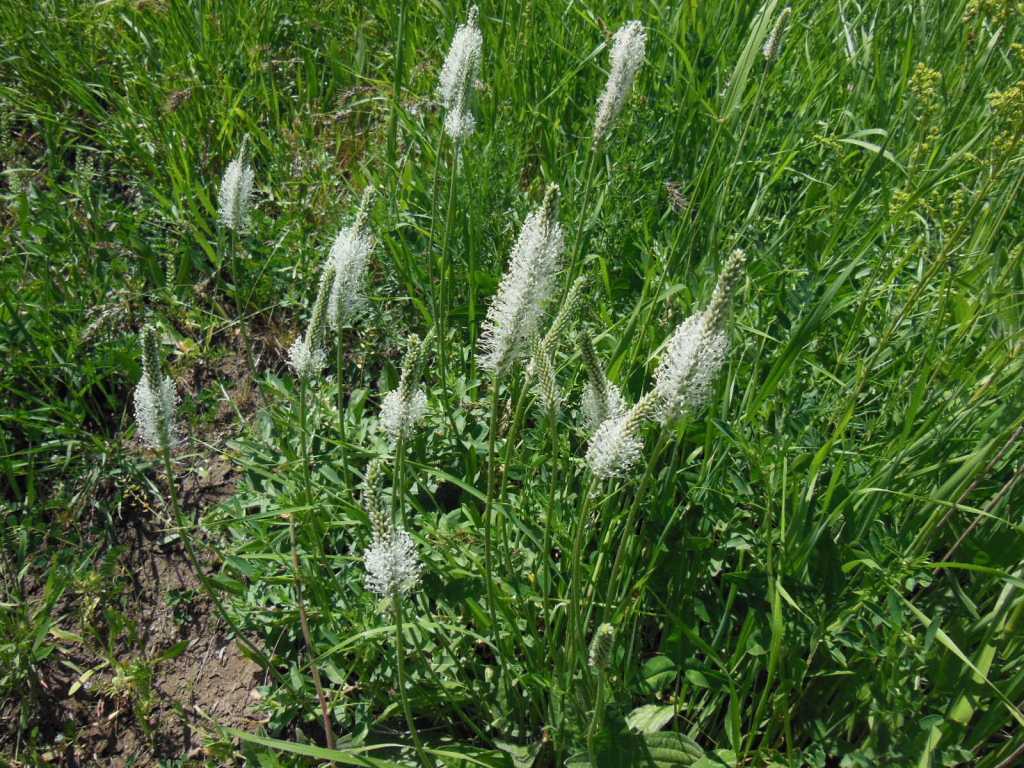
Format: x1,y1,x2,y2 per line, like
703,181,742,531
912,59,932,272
0,0,1024,767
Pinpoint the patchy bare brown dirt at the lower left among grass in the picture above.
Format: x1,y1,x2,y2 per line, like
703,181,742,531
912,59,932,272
0,357,265,768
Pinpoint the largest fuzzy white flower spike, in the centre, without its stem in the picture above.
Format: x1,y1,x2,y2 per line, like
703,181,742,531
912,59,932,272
480,184,565,374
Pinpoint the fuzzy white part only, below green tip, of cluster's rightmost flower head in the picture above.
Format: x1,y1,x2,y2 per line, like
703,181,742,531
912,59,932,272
654,312,729,422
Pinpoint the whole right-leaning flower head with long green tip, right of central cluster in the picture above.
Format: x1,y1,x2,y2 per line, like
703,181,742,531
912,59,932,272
654,248,746,423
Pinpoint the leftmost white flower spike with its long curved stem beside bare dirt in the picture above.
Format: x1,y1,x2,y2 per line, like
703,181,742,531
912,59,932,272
135,326,274,674
